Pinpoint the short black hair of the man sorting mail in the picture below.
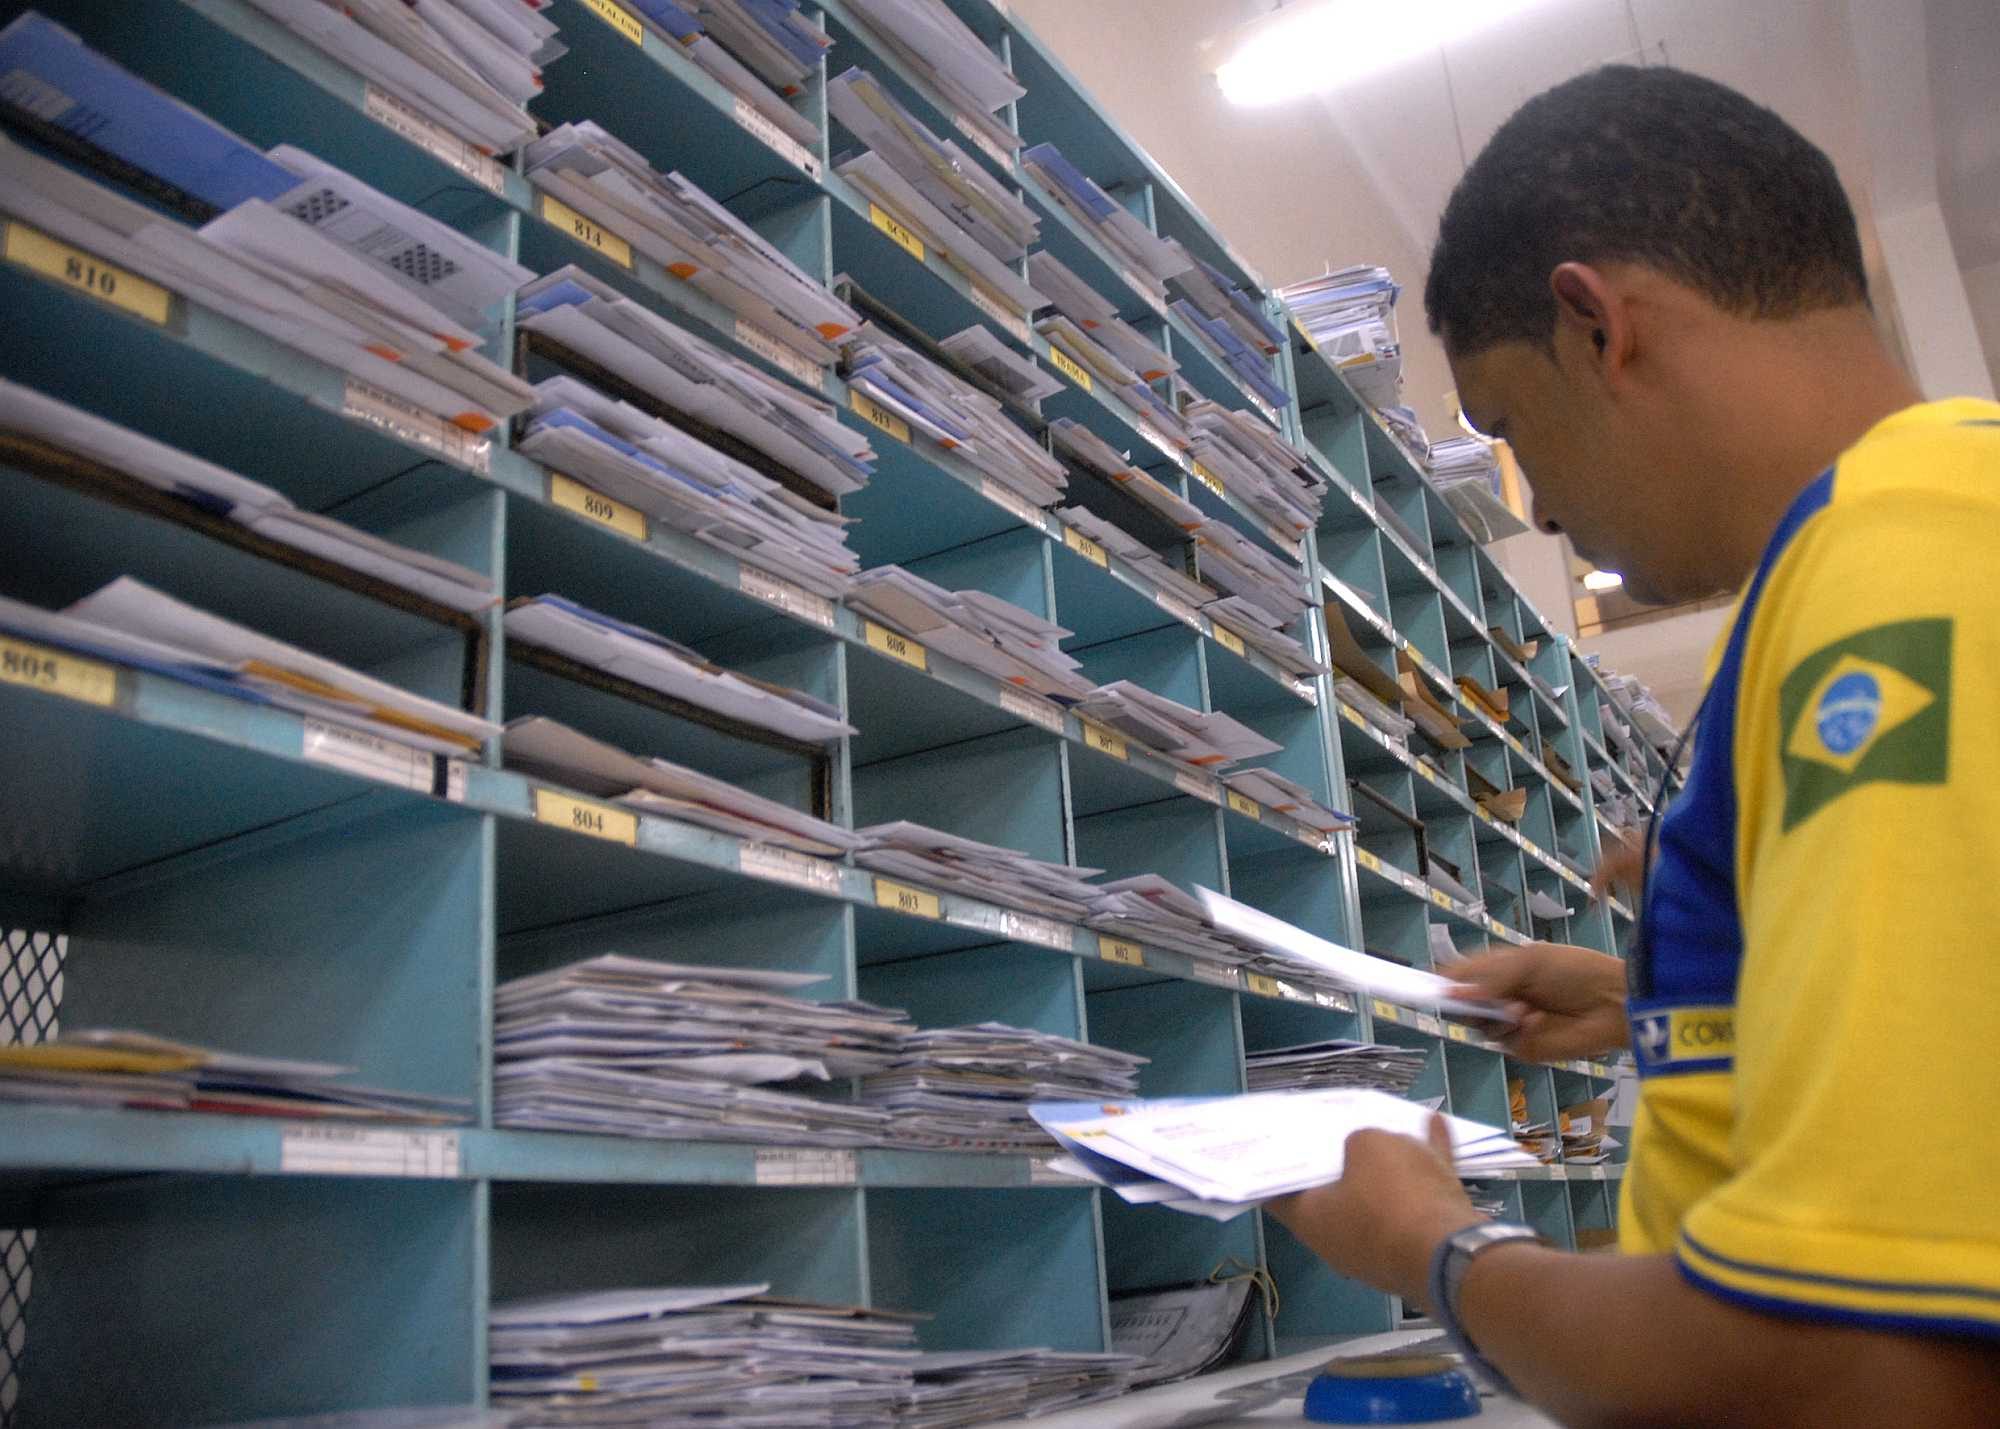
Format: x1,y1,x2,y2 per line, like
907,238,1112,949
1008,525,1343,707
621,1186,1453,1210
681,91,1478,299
1424,64,1868,354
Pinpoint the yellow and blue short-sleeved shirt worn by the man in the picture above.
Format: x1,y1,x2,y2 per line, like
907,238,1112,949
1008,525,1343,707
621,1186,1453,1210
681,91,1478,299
1620,400,2000,1335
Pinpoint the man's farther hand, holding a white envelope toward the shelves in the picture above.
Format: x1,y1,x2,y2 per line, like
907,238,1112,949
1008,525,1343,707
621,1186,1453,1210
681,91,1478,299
1446,943,1630,1063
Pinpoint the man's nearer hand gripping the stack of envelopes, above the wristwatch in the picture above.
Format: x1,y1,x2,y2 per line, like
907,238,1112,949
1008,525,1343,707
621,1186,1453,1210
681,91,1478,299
1264,1117,1486,1305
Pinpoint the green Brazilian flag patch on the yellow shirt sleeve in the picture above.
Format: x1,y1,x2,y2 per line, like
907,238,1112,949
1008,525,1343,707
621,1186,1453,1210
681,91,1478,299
1778,616,1952,831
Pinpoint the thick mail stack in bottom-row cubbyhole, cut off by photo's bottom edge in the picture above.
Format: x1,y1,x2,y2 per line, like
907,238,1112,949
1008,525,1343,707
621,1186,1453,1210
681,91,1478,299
486,1283,918,1429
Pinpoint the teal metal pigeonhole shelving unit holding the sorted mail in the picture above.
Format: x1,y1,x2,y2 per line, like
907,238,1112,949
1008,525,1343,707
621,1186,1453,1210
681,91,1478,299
0,0,1660,1425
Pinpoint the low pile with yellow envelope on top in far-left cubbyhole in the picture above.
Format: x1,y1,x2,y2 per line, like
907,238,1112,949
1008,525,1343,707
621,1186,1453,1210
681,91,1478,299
0,1031,472,1123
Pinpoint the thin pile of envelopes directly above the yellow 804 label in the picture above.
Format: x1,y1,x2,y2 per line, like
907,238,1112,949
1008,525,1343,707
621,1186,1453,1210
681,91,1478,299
500,717,860,852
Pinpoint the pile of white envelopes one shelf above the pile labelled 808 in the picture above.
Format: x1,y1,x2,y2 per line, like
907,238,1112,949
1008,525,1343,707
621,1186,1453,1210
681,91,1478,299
846,322,1070,506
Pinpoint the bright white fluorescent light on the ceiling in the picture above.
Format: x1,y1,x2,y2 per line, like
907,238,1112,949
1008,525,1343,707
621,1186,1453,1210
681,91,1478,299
1216,0,1542,106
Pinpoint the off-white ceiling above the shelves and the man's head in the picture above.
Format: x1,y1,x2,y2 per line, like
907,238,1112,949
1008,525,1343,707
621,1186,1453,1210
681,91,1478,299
1012,0,2000,426
